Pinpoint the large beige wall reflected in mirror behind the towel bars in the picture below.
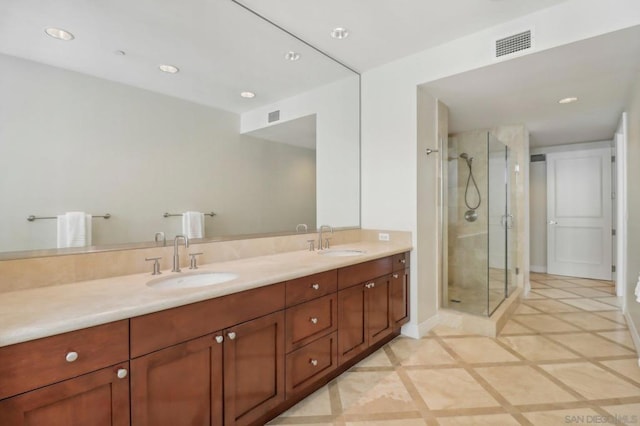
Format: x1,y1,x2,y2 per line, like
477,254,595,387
0,55,316,251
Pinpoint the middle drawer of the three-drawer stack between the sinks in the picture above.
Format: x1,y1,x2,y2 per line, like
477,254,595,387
285,294,338,352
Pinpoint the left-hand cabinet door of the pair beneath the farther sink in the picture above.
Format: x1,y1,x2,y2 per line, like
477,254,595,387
338,285,367,364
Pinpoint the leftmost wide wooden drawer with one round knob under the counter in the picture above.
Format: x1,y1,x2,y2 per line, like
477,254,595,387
0,320,129,399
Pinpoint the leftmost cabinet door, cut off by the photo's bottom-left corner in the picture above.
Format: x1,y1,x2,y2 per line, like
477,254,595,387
0,363,129,426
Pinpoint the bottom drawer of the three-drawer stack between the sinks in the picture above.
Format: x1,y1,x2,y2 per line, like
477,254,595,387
286,333,338,398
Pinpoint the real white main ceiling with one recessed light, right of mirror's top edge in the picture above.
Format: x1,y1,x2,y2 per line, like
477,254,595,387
234,0,566,72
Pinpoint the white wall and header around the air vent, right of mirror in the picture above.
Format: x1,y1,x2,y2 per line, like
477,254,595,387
361,0,640,330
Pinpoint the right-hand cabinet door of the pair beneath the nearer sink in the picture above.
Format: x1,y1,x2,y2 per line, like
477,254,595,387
224,311,285,426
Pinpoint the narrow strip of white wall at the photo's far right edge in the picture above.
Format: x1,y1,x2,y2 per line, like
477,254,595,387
625,73,640,348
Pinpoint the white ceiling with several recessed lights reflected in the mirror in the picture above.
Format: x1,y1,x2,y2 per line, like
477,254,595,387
0,0,353,113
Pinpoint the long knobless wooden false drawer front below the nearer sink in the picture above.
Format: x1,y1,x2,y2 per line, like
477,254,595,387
131,283,284,358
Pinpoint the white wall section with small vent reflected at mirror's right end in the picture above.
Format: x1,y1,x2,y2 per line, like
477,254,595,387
240,75,360,227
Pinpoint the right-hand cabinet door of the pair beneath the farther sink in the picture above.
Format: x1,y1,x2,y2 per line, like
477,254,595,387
365,276,393,346
